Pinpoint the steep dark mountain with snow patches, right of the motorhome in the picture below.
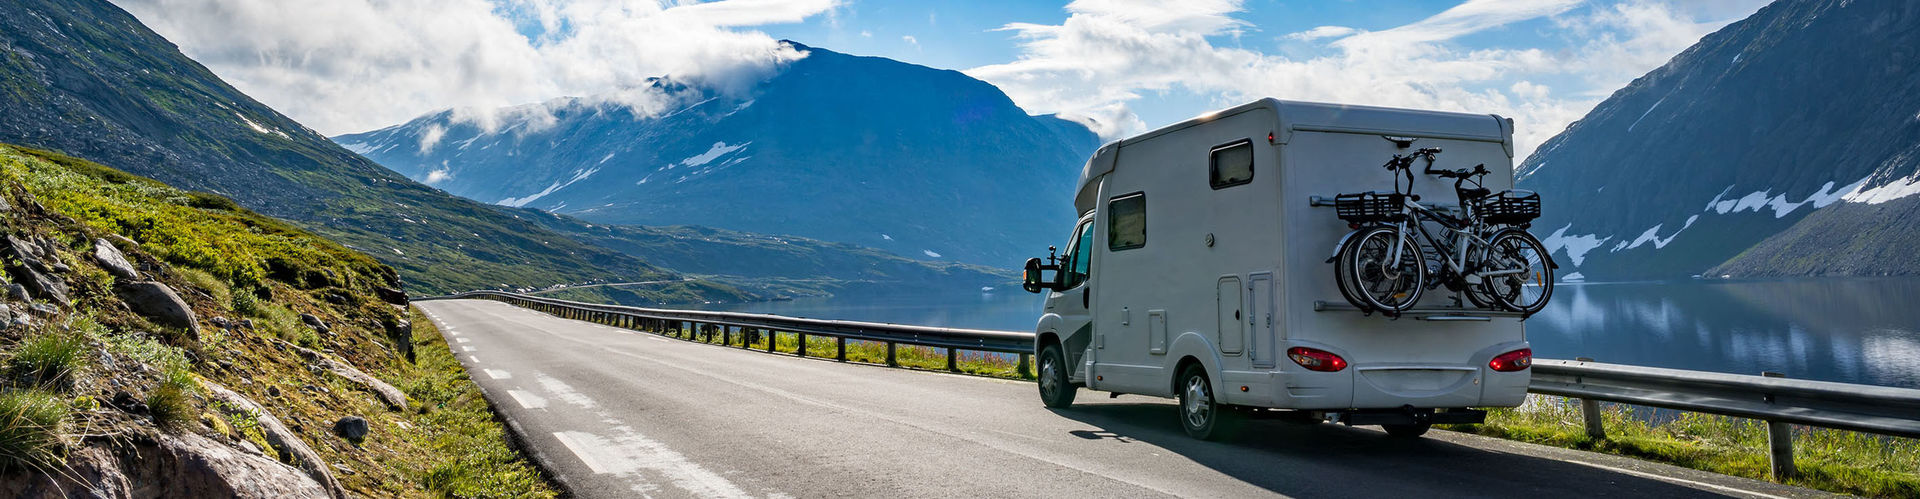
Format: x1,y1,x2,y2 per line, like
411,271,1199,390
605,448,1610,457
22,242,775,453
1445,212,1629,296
1519,0,1920,280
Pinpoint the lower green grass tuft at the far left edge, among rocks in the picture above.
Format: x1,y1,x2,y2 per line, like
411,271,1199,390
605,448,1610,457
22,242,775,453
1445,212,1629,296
0,390,71,470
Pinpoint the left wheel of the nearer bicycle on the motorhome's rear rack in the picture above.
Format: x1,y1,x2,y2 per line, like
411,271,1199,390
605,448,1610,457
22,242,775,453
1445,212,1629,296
1346,226,1427,315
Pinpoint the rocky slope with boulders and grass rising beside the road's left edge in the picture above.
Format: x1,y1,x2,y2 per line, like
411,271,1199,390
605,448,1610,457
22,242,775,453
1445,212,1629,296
0,144,553,497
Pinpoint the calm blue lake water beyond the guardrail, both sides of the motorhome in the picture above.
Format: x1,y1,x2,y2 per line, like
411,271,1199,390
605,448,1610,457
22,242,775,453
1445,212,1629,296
698,278,1920,388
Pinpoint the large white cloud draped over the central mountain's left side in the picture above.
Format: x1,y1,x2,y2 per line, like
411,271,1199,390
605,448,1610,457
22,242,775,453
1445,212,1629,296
113,0,841,135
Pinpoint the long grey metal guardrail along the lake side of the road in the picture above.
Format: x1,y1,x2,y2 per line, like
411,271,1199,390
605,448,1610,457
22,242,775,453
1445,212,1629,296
424,292,1920,478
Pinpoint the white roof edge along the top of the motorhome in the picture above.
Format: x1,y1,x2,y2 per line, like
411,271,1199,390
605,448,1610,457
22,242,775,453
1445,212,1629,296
1075,98,1513,213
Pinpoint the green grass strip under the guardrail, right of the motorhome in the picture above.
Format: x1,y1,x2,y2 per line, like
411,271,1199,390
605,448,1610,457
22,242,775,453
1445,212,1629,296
1450,395,1920,497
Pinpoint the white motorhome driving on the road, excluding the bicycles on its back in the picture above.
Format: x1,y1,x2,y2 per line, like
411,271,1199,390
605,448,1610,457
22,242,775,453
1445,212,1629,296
1027,98,1532,438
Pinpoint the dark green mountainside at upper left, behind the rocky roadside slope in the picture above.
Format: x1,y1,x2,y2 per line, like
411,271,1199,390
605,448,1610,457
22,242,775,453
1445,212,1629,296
0,0,706,294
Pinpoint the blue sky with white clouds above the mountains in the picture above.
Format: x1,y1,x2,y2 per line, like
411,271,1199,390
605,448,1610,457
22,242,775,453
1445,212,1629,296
113,0,1766,157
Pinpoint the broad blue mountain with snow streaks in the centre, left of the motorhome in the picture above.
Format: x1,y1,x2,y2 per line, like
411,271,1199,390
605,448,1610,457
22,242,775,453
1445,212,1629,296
334,42,1098,269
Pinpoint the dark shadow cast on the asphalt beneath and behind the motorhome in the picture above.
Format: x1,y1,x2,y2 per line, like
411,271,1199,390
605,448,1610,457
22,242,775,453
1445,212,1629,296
1054,401,1722,497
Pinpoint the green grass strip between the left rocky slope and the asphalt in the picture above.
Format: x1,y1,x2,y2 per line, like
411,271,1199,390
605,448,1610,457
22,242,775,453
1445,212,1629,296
384,307,557,497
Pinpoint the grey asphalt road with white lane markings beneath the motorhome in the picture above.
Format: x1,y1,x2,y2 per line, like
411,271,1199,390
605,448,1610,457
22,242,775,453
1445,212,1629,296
419,299,1824,497
